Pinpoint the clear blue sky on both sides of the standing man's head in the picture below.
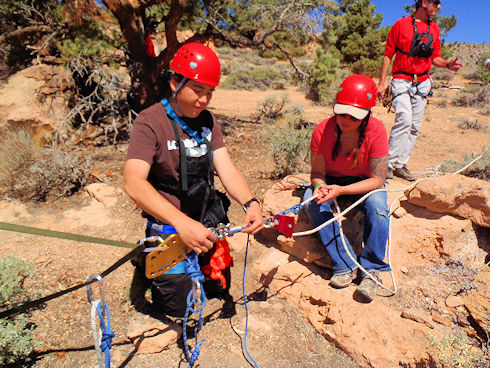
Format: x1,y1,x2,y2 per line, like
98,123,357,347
371,0,490,43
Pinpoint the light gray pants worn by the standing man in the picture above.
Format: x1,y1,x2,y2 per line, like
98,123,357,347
388,78,432,169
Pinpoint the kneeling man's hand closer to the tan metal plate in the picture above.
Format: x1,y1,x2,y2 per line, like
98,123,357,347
174,216,218,254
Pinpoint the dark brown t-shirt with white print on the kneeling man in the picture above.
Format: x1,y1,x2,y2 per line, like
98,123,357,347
127,102,225,209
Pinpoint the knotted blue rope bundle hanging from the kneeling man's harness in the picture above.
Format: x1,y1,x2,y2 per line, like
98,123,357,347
183,252,206,367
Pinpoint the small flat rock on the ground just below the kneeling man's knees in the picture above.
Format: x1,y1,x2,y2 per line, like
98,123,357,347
127,316,182,354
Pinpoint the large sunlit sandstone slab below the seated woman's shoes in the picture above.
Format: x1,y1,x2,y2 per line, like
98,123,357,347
256,261,436,368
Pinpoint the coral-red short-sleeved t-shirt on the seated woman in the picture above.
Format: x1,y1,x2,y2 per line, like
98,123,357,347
310,116,389,177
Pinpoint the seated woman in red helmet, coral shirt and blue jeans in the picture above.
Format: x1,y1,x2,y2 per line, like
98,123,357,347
303,74,390,301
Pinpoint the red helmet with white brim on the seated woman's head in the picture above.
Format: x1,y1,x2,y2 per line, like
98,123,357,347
333,74,378,119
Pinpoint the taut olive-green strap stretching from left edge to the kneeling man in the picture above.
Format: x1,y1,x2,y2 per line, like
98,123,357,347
0,222,138,248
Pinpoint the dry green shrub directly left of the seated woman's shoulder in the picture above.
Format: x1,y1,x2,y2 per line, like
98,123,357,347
264,122,312,178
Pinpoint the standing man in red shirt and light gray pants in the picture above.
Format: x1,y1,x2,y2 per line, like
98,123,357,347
378,0,462,181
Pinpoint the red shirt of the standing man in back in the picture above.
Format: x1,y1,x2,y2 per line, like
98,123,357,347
385,16,441,82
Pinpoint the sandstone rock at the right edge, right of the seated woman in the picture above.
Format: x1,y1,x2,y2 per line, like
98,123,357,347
405,175,490,227
